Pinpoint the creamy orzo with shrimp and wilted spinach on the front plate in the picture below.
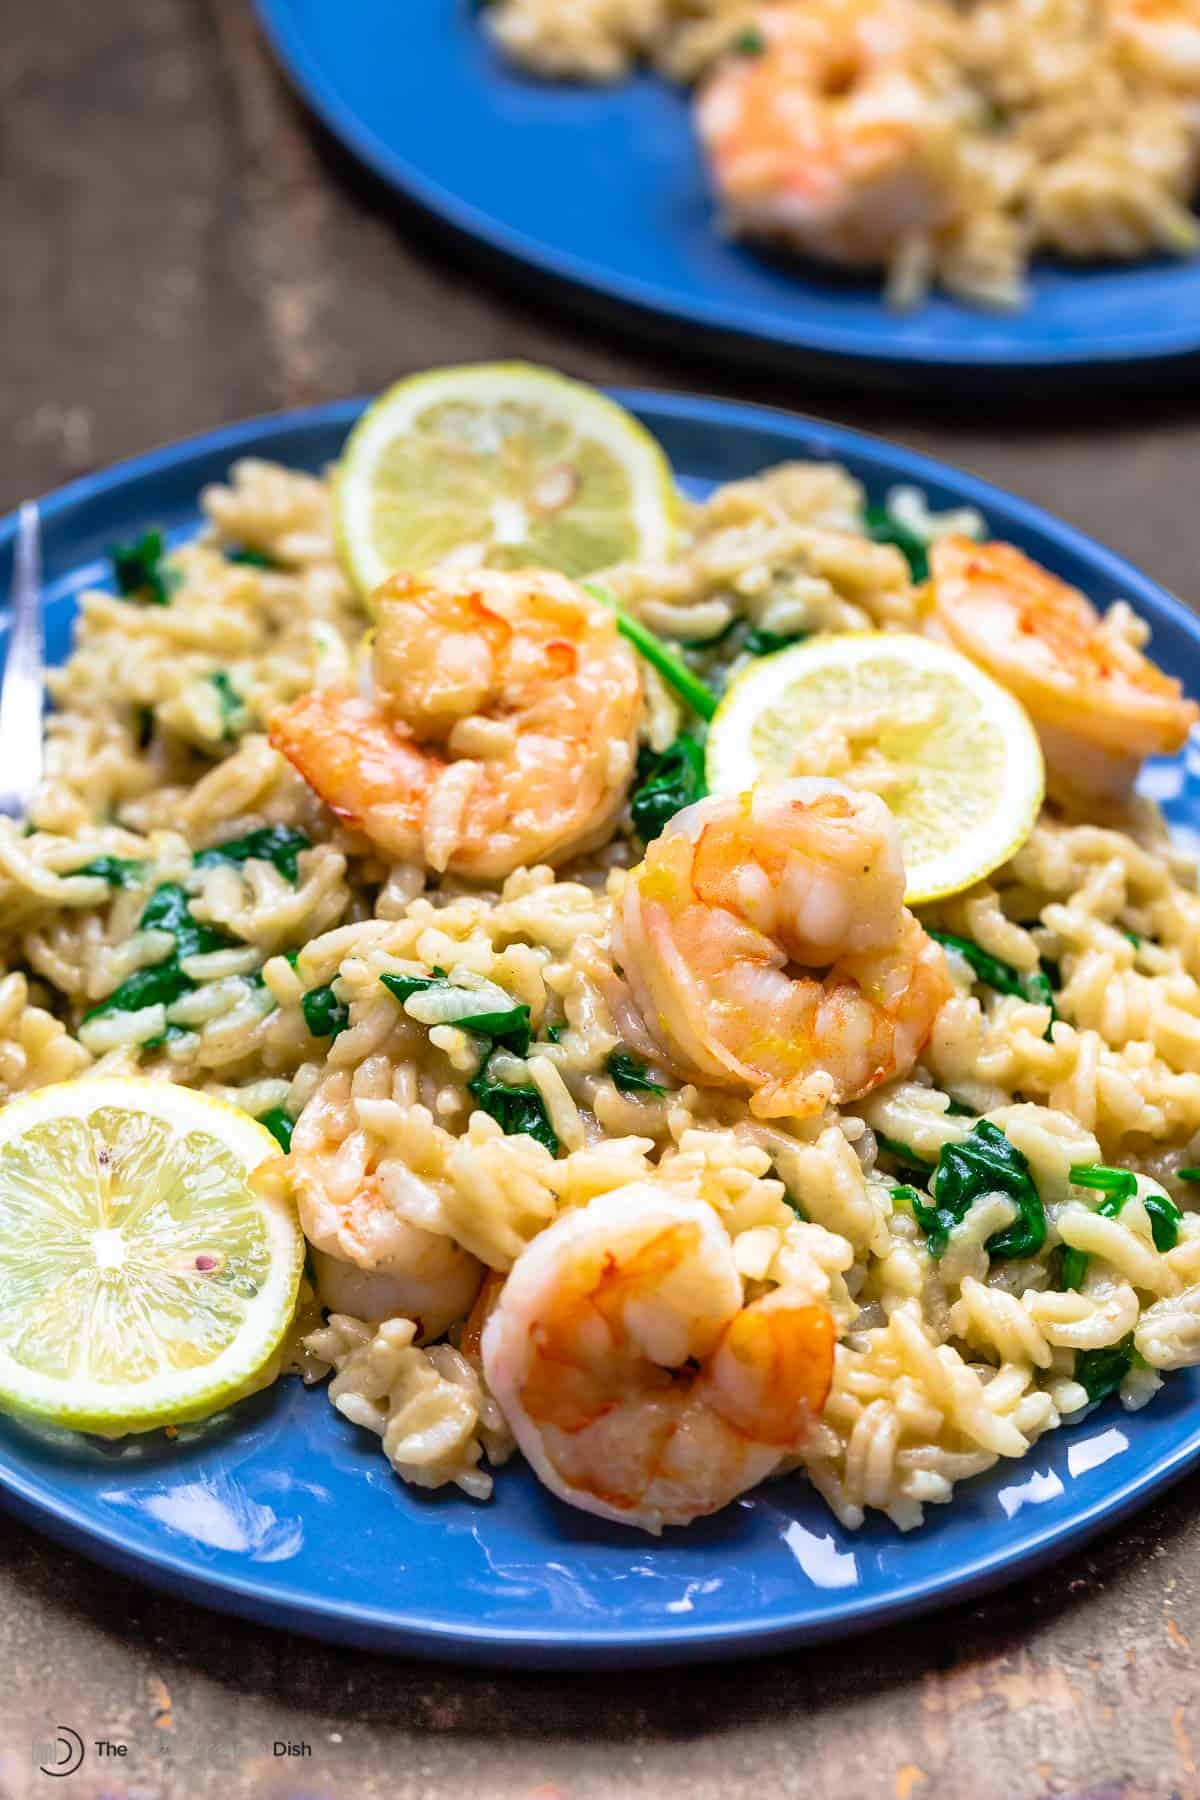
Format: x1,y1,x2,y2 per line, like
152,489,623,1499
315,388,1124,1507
9,417,1200,1530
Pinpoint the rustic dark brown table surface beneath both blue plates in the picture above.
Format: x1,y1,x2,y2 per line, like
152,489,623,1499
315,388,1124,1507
0,0,1200,1800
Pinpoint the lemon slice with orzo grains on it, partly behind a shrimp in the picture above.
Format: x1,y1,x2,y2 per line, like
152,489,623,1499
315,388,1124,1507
707,632,1045,905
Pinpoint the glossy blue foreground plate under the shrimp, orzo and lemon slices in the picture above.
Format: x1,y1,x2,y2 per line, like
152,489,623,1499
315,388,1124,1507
0,394,1200,1665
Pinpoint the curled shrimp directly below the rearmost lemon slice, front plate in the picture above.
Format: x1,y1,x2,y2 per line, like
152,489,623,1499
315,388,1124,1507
270,571,640,880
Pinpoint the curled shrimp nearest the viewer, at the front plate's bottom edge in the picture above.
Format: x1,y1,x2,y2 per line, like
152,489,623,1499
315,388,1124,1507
482,1183,835,1532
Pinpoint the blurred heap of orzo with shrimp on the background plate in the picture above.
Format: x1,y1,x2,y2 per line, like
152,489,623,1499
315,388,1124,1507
486,0,1200,308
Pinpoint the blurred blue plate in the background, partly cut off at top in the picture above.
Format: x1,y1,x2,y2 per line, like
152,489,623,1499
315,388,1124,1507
246,0,1200,378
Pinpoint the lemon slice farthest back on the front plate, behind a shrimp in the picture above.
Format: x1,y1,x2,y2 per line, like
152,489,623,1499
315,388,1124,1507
335,362,680,594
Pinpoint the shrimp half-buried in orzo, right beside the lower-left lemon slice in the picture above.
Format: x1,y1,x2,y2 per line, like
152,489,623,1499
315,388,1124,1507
291,1163,484,1339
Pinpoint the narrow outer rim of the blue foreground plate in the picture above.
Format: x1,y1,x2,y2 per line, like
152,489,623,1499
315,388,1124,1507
0,389,1200,1667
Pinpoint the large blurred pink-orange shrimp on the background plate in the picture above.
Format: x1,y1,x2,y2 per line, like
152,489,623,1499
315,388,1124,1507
696,0,954,268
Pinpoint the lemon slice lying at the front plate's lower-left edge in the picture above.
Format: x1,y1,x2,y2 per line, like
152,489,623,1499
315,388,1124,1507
0,1078,304,1436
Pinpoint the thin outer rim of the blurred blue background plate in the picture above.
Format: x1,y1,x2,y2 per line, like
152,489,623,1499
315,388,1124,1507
252,0,1200,374
